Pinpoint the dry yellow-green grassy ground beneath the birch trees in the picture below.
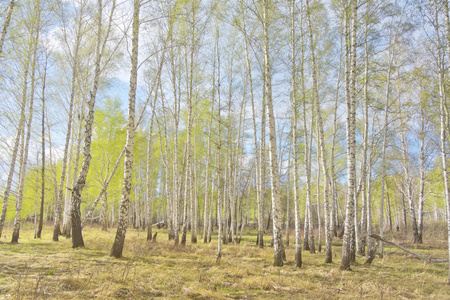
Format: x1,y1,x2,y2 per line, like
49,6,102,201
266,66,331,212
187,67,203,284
0,224,450,299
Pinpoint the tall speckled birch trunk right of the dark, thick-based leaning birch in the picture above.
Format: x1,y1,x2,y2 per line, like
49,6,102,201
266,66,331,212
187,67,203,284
110,0,141,258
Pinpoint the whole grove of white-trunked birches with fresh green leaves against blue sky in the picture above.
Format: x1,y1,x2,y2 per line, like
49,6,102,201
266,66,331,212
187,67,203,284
0,0,450,282
